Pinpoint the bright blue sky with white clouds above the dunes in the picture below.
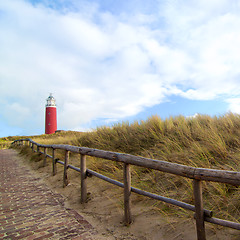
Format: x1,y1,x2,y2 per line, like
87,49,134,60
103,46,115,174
0,0,240,137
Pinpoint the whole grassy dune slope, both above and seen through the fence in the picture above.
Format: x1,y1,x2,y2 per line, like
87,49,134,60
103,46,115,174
7,114,240,221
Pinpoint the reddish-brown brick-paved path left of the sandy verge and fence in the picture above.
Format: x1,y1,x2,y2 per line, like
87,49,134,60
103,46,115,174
0,149,96,240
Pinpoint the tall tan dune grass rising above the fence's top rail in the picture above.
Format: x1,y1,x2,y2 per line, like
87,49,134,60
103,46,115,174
73,114,240,167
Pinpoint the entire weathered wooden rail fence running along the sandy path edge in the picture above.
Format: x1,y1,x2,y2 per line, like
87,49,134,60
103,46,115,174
12,138,240,240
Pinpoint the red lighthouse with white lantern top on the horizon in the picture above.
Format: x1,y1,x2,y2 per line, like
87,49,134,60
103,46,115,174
45,93,57,134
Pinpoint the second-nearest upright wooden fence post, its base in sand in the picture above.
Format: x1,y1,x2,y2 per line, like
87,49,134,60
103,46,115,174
123,163,132,225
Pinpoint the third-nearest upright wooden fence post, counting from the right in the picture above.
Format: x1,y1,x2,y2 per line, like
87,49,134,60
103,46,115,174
80,154,87,203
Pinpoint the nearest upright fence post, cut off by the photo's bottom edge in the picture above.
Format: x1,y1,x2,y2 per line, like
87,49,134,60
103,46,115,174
193,179,206,240
